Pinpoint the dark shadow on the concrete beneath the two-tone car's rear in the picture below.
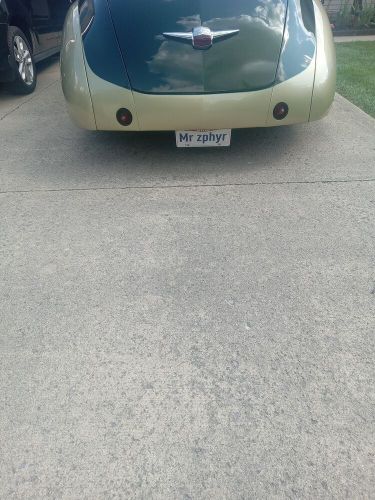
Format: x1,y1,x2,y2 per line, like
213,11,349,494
70,125,308,179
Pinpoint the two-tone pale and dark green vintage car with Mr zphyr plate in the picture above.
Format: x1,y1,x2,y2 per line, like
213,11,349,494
61,0,336,147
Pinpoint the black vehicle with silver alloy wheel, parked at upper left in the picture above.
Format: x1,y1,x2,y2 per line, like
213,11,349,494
0,0,70,94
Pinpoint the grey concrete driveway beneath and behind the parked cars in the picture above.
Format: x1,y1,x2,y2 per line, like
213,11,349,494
0,61,375,500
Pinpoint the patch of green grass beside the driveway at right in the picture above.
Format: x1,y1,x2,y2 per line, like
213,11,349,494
336,42,375,118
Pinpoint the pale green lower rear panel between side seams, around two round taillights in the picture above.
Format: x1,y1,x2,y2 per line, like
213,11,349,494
82,53,315,131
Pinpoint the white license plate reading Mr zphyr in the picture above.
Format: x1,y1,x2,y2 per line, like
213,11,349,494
176,129,232,148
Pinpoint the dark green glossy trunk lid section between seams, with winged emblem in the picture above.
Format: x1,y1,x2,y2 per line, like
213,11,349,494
108,0,287,94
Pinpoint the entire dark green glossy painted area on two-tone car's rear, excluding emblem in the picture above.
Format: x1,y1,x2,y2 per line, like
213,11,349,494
83,0,316,94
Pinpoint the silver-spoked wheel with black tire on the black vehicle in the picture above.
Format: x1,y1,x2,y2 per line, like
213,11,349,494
8,26,36,94
